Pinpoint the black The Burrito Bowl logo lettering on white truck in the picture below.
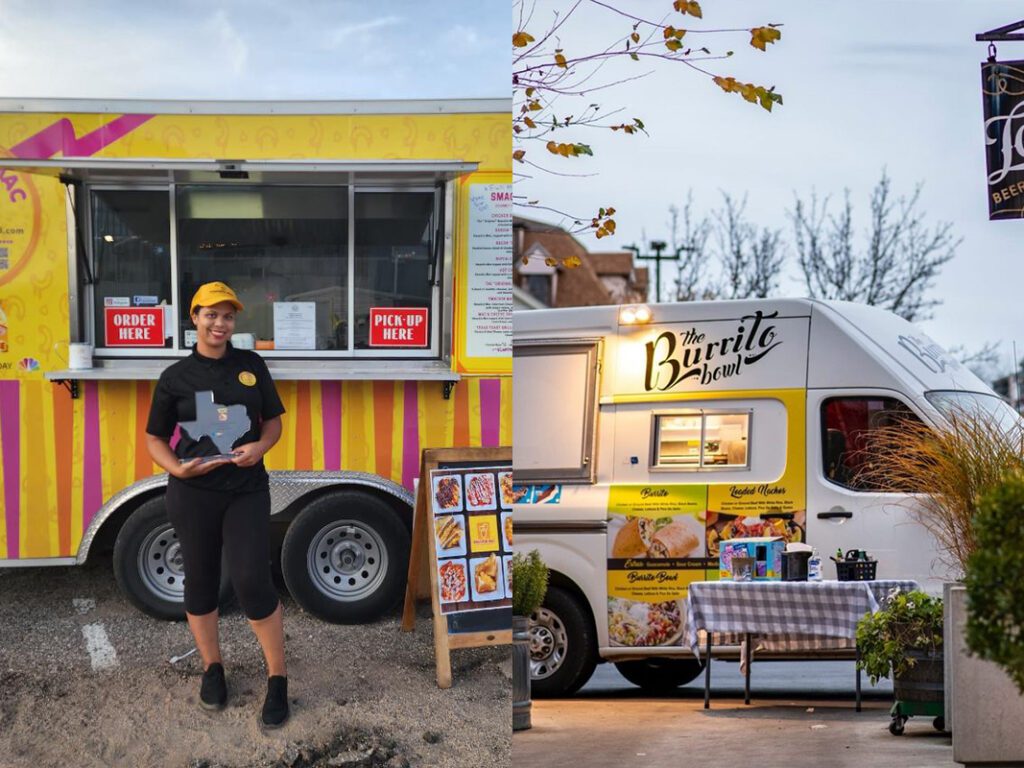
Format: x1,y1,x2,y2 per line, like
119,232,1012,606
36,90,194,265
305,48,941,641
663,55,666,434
644,309,782,392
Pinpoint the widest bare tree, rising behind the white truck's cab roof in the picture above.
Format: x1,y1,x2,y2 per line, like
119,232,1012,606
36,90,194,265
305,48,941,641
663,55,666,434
790,171,962,321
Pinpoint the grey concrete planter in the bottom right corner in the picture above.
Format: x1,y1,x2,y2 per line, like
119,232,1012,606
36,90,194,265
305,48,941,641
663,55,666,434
945,585,1024,768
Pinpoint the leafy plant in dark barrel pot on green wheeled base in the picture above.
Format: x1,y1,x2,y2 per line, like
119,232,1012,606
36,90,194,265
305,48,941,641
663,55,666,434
857,591,944,735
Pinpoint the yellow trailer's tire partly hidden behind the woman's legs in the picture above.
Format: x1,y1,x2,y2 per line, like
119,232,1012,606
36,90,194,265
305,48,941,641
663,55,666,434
114,495,233,622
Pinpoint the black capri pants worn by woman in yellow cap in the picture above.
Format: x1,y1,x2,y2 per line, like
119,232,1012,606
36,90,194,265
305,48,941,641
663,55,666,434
166,477,279,622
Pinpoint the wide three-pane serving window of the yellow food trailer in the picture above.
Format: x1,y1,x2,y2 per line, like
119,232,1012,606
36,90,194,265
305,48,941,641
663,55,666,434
84,183,443,357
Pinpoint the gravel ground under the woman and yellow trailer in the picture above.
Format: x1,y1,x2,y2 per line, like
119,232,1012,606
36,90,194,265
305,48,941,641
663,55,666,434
0,557,512,768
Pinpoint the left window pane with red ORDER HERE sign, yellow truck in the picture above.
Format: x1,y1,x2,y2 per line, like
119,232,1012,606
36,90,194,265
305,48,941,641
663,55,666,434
90,189,173,349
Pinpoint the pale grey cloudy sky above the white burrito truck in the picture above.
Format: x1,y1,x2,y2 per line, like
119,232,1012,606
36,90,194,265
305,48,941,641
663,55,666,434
520,0,1024,376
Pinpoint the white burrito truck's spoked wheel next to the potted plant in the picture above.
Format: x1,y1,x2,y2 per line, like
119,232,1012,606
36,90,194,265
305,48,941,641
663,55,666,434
529,587,597,698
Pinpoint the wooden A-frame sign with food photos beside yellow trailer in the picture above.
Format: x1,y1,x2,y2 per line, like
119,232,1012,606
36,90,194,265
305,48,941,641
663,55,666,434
401,447,512,688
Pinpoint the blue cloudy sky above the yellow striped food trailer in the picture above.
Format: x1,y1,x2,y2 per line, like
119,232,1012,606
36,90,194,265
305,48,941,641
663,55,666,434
0,0,510,99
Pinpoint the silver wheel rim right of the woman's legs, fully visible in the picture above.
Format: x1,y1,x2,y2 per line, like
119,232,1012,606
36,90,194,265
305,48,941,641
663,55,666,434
306,520,388,602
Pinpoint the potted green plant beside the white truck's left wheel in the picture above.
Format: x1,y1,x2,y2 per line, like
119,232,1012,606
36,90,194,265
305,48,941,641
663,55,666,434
512,549,549,731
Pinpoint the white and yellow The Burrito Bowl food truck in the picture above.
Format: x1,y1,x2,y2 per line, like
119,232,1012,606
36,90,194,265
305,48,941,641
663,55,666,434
513,299,1016,695
